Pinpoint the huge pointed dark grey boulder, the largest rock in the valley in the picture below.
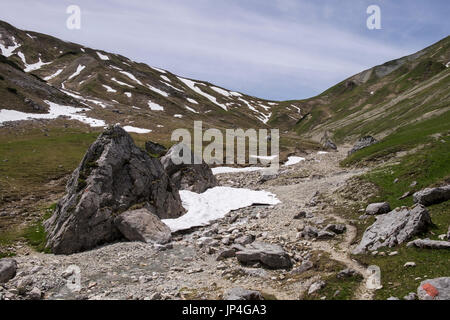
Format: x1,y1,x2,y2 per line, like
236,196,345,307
45,126,184,254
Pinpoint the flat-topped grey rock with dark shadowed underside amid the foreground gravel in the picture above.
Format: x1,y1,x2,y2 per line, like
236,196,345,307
236,241,292,269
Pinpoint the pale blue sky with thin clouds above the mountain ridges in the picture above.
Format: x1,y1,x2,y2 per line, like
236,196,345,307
0,0,450,100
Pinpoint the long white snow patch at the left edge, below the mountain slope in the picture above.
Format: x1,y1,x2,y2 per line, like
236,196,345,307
0,101,106,127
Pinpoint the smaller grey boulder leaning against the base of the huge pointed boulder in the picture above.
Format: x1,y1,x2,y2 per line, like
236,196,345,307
114,208,171,244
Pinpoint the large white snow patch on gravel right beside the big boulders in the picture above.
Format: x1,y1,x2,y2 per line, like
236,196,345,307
162,187,280,232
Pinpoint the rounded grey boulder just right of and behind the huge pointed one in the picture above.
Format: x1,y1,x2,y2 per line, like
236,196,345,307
161,143,218,193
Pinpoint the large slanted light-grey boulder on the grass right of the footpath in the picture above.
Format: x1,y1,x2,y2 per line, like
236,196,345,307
353,205,431,254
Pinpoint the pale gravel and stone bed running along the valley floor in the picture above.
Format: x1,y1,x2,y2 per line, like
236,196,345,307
2,148,384,299
